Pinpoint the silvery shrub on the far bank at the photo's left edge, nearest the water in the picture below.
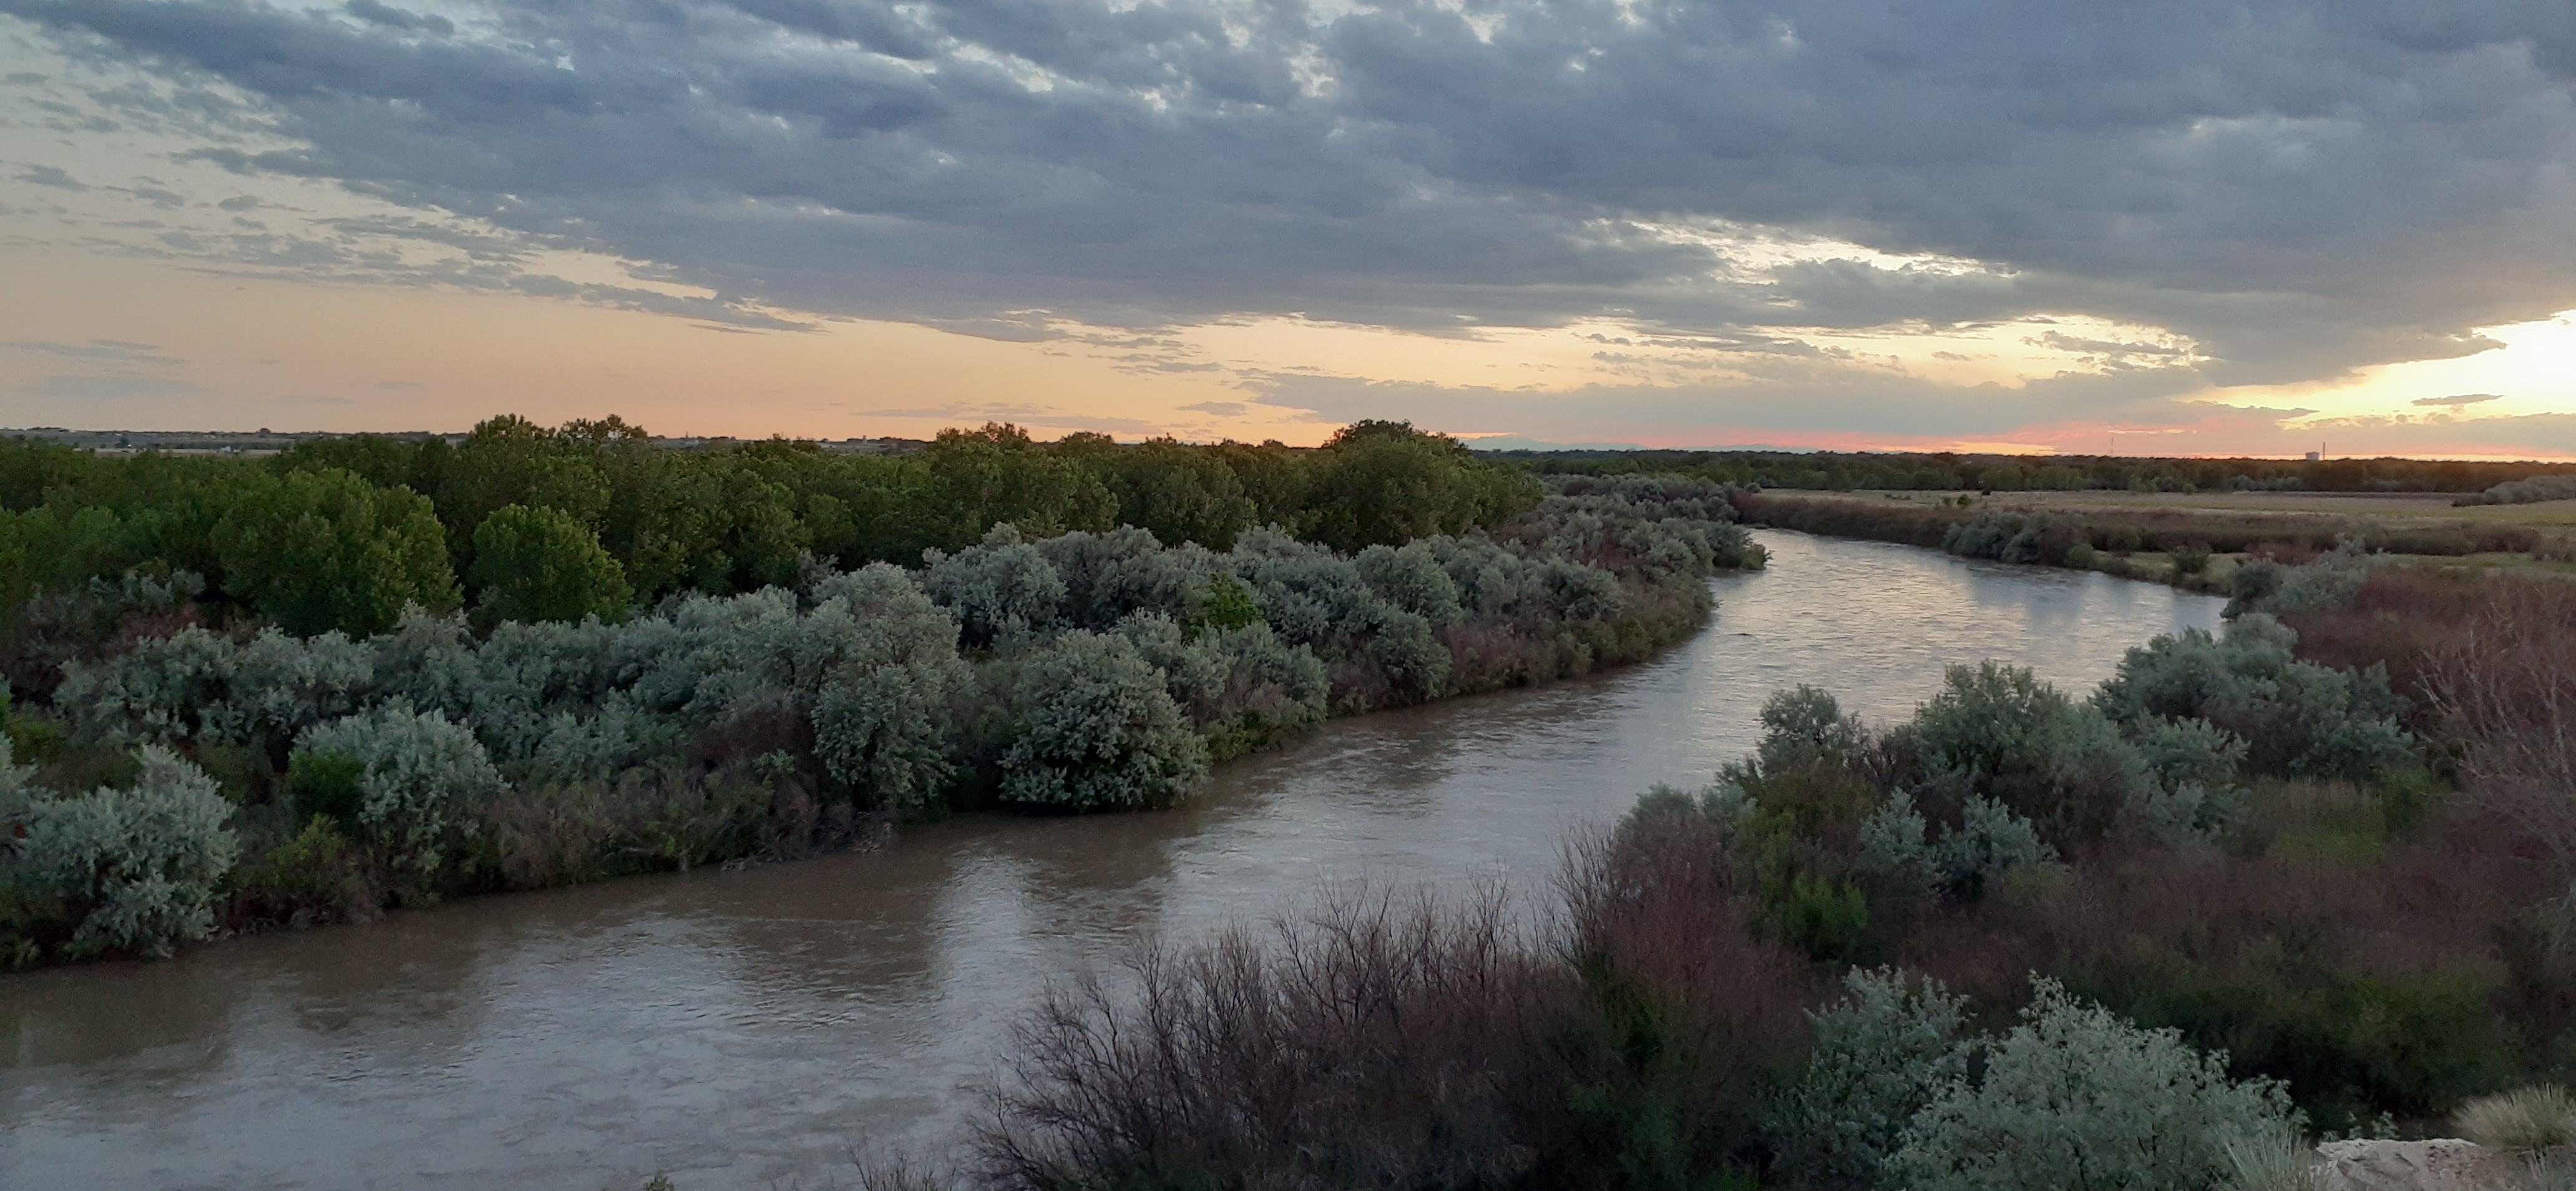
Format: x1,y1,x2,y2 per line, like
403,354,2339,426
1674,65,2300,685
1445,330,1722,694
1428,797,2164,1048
0,737,240,956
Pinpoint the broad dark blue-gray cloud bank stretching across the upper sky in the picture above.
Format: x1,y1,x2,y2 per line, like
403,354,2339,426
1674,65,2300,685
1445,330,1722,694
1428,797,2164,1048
15,0,2576,389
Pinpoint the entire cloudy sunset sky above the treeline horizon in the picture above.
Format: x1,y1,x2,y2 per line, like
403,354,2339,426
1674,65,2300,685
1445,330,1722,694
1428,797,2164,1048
0,0,2576,456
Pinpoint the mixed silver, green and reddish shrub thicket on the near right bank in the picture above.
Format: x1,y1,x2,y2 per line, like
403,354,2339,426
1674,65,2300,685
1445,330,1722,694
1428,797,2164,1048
966,559,2576,1191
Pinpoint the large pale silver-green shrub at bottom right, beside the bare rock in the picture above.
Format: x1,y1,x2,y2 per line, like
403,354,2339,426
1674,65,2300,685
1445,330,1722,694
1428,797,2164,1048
1888,979,2295,1191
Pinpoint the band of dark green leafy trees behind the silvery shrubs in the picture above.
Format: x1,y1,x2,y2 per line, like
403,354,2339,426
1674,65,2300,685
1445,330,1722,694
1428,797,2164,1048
0,418,1541,691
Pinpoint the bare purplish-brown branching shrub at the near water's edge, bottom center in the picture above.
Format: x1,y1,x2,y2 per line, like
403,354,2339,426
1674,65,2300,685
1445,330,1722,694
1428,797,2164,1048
979,890,1566,1186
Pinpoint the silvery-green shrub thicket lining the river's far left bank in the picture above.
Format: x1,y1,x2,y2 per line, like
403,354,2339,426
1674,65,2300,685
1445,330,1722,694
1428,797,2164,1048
0,477,1762,961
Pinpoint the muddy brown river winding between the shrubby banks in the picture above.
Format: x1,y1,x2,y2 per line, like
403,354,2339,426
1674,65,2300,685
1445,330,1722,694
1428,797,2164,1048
0,534,2218,1191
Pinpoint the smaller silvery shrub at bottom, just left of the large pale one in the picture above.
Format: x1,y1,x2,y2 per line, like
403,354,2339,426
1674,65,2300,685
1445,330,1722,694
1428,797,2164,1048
1765,969,1971,1186
